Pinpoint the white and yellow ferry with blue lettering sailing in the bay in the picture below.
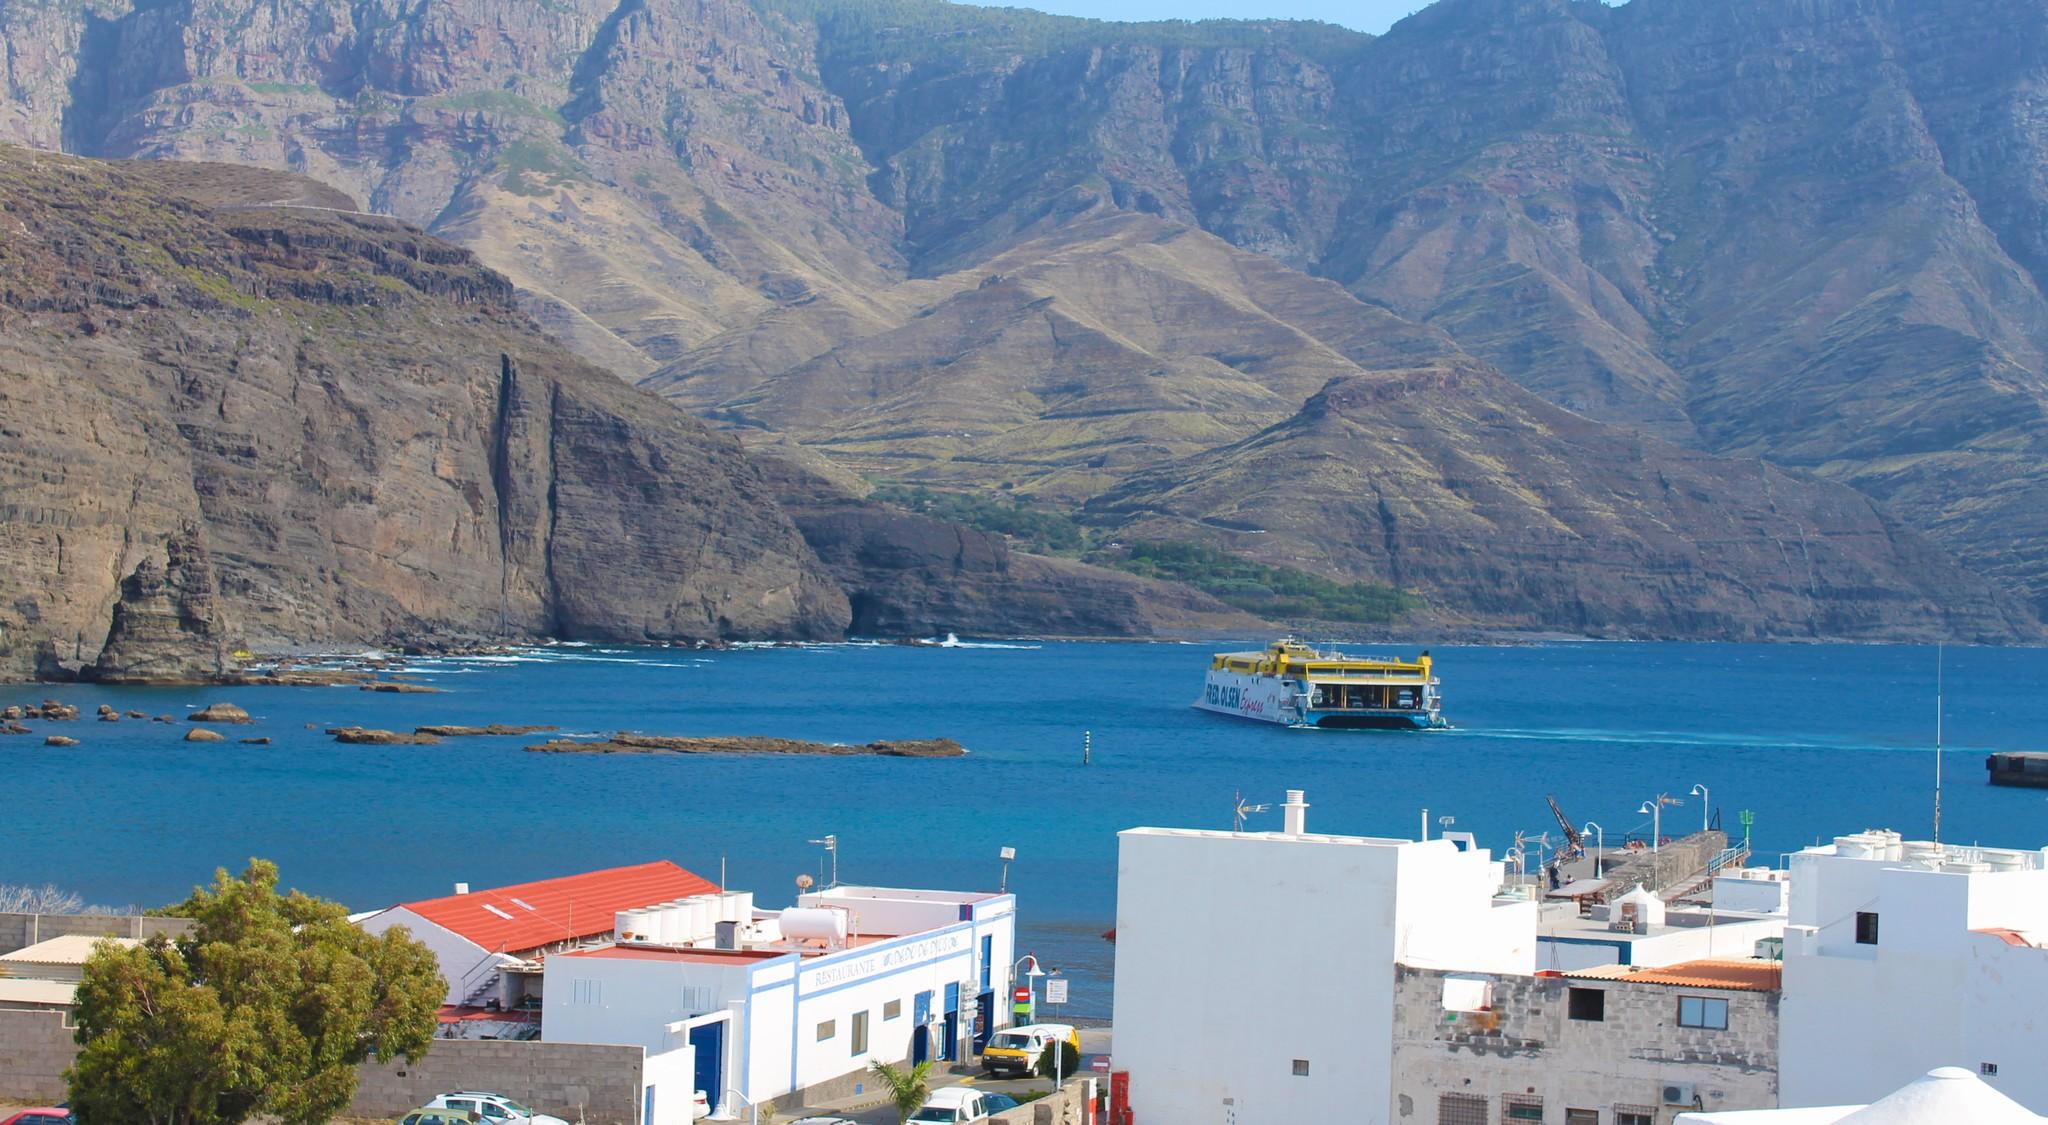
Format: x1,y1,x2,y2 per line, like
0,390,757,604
1194,637,1450,730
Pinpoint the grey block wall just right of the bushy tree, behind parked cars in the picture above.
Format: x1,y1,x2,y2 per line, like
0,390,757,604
348,1039,643,1125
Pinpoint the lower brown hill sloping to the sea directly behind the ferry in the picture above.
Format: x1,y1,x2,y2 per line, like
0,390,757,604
1087,363,2038,641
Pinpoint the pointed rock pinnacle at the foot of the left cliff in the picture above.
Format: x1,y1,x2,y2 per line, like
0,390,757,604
88,523,227,684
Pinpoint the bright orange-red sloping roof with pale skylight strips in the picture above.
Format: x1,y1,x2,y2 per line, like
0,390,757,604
399,859,719,953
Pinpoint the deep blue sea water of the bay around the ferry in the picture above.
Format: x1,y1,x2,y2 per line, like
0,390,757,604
0,637,2048,1016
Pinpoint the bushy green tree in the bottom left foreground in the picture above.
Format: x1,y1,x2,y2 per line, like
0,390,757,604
66,859,446,1125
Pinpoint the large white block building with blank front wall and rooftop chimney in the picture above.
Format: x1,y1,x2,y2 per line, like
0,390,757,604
1116,791,1536,1125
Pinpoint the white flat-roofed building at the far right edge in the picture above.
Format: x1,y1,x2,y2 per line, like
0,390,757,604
1780,830,2048,1113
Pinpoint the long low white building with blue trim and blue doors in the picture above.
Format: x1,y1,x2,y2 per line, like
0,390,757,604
541,887,1016,1109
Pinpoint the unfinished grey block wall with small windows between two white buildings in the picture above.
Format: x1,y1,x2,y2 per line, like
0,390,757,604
1393,965,1778,1125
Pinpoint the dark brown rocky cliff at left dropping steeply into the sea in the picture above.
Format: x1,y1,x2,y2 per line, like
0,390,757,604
0,145,848,678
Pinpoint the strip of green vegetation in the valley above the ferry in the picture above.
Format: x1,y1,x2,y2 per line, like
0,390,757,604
868,484,1421,625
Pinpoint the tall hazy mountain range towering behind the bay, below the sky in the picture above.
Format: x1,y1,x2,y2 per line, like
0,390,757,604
12,0,2048,635
